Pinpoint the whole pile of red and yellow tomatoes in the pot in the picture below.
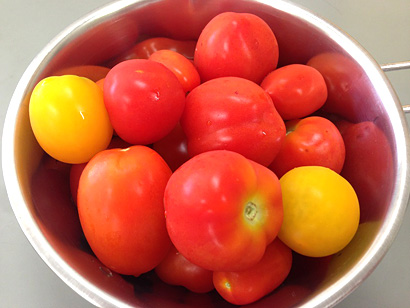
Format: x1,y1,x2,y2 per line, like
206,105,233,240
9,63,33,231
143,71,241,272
29,12,360,305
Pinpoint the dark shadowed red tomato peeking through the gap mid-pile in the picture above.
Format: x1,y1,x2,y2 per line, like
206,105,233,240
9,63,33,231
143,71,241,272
152,123,190,171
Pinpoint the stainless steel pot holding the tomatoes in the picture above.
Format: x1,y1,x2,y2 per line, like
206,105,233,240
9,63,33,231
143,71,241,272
2,0,409,307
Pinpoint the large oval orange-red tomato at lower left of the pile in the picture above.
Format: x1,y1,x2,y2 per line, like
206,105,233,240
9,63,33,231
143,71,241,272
77,146,171,276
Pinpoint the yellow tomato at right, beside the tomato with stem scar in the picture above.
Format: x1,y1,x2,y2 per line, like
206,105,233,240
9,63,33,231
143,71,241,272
278,166,360,257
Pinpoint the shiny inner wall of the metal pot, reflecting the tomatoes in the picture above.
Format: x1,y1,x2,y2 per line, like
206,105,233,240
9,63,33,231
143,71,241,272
11,0,397,307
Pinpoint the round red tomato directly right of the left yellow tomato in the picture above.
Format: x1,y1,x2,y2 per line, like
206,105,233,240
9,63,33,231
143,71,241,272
104,59,185,144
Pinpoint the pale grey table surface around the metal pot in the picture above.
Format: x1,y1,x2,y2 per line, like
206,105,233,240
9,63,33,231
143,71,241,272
0,0,410,308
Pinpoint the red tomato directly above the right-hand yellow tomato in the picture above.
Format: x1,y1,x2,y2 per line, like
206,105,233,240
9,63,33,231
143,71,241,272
269,116,346,177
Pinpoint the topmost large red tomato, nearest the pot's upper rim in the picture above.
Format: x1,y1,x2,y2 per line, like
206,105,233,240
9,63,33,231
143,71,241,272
194,12,279,84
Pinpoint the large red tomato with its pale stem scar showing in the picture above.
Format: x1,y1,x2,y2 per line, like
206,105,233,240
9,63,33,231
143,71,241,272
165,150,283,271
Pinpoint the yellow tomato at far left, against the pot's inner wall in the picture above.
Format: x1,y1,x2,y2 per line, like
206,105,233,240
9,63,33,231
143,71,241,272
29,75,113,164
